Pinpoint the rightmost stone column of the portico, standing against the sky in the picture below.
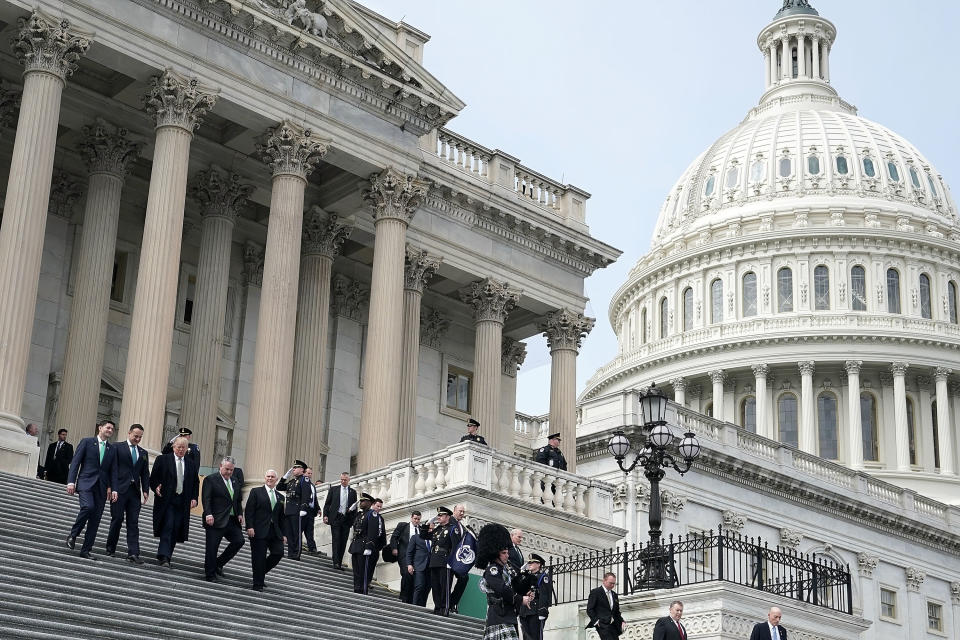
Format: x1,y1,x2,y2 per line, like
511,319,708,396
540,309,596,473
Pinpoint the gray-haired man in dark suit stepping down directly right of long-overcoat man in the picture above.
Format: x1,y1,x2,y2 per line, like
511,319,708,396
202,457,243,582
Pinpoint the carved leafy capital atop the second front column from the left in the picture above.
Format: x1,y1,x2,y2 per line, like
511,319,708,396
142,69,220,131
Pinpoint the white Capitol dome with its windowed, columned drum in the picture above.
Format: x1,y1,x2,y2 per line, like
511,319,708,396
581,0,960,504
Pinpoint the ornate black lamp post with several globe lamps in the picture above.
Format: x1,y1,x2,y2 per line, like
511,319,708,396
607,384,700,589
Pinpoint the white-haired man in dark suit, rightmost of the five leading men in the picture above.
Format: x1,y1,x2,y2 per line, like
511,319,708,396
243,469,287,591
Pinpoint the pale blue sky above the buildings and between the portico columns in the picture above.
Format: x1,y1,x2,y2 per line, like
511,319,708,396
361,0,960,414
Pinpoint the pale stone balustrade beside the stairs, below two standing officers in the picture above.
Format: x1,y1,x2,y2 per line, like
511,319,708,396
338,442,614,524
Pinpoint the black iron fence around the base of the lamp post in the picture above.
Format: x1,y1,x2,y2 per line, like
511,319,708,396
549,527,853,613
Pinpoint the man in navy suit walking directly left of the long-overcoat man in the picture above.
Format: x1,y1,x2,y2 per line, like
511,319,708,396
107,424,150,564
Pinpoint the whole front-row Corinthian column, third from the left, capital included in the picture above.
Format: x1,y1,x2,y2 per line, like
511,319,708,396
247,121,329,482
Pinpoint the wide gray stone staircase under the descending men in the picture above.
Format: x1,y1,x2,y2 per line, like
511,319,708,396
0,473,483,640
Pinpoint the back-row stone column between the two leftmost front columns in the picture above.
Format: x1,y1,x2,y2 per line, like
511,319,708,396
55,119,141,442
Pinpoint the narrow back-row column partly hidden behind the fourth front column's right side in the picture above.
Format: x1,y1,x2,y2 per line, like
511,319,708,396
397,247,442,460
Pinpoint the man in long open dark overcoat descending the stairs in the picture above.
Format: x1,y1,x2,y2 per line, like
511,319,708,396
150,438,200,569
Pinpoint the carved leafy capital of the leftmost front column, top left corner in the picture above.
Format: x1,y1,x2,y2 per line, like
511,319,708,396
12,11,92,80
